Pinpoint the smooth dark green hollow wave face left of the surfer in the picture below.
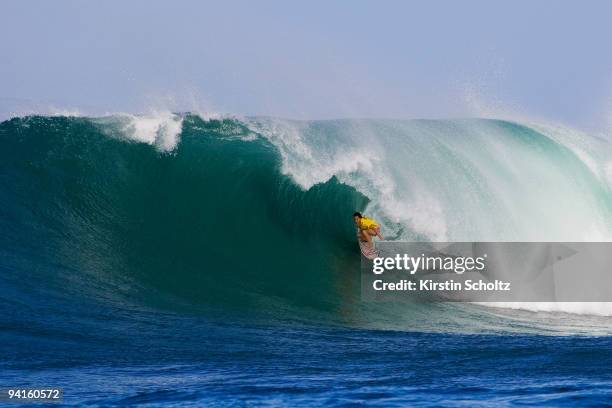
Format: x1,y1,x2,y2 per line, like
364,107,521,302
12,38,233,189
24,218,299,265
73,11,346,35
0,117,367,313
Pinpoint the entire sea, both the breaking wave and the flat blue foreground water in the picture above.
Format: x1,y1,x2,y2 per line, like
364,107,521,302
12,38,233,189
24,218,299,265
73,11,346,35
0,114,612,406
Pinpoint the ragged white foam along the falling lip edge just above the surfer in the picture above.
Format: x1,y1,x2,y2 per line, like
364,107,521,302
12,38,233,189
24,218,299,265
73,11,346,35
249,120,447,241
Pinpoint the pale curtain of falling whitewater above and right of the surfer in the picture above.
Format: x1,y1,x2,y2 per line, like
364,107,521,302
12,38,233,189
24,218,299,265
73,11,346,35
249,119,612,242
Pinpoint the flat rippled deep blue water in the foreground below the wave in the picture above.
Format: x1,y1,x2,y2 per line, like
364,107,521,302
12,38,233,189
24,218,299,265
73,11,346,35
2,314,612,406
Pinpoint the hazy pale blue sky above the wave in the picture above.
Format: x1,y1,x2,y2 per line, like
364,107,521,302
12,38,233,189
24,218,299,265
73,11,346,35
0,0,612,128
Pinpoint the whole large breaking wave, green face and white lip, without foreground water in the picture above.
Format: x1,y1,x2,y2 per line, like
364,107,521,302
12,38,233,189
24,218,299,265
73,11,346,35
0,113,612,327
